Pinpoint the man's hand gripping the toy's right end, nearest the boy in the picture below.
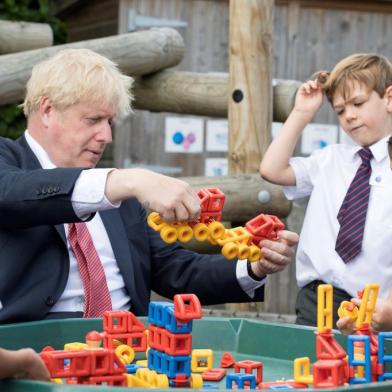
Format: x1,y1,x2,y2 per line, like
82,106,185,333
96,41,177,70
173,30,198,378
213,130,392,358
251,230,299,278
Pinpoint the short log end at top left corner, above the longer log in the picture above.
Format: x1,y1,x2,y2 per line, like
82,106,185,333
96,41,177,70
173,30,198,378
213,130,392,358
0,20,53,54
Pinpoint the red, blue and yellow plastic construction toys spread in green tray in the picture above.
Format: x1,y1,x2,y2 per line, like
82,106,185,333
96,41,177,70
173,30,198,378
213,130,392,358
33,284,392,390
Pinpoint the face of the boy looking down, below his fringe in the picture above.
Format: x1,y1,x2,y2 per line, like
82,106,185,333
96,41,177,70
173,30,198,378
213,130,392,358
332,81,392,146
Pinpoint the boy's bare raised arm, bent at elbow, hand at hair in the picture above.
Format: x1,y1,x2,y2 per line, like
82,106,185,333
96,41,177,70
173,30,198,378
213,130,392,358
260,80,323,185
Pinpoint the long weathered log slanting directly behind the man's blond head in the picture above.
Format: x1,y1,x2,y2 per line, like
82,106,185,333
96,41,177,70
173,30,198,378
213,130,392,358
0,28,184,105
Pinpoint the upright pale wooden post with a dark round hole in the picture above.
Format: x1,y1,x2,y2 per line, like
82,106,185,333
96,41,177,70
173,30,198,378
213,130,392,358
228,0,274,174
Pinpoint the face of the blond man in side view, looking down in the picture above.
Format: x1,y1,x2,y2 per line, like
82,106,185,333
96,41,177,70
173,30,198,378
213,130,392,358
43,103,116,168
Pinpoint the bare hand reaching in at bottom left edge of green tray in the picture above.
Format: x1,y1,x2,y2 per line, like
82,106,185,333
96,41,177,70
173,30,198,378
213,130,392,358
0,348,50,381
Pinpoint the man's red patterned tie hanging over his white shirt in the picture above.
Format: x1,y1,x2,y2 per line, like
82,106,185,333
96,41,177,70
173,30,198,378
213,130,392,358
68,223,112,318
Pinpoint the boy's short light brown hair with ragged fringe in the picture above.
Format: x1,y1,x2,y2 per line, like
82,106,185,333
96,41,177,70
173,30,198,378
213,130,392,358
315,53,392,102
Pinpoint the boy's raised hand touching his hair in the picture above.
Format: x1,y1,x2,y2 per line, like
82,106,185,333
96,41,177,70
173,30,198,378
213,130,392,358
294,80,323,121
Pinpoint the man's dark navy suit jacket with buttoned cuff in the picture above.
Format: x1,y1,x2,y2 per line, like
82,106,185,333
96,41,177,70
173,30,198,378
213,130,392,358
0,137,264,323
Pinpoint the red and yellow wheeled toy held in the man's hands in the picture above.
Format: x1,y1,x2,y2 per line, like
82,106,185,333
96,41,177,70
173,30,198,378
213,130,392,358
147,188,285,262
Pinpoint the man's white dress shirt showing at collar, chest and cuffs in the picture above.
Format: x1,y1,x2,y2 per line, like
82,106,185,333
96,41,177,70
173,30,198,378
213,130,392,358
25,130,266,312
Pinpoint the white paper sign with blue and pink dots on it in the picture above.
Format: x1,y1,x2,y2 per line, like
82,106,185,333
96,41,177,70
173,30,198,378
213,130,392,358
165,117,204,153
